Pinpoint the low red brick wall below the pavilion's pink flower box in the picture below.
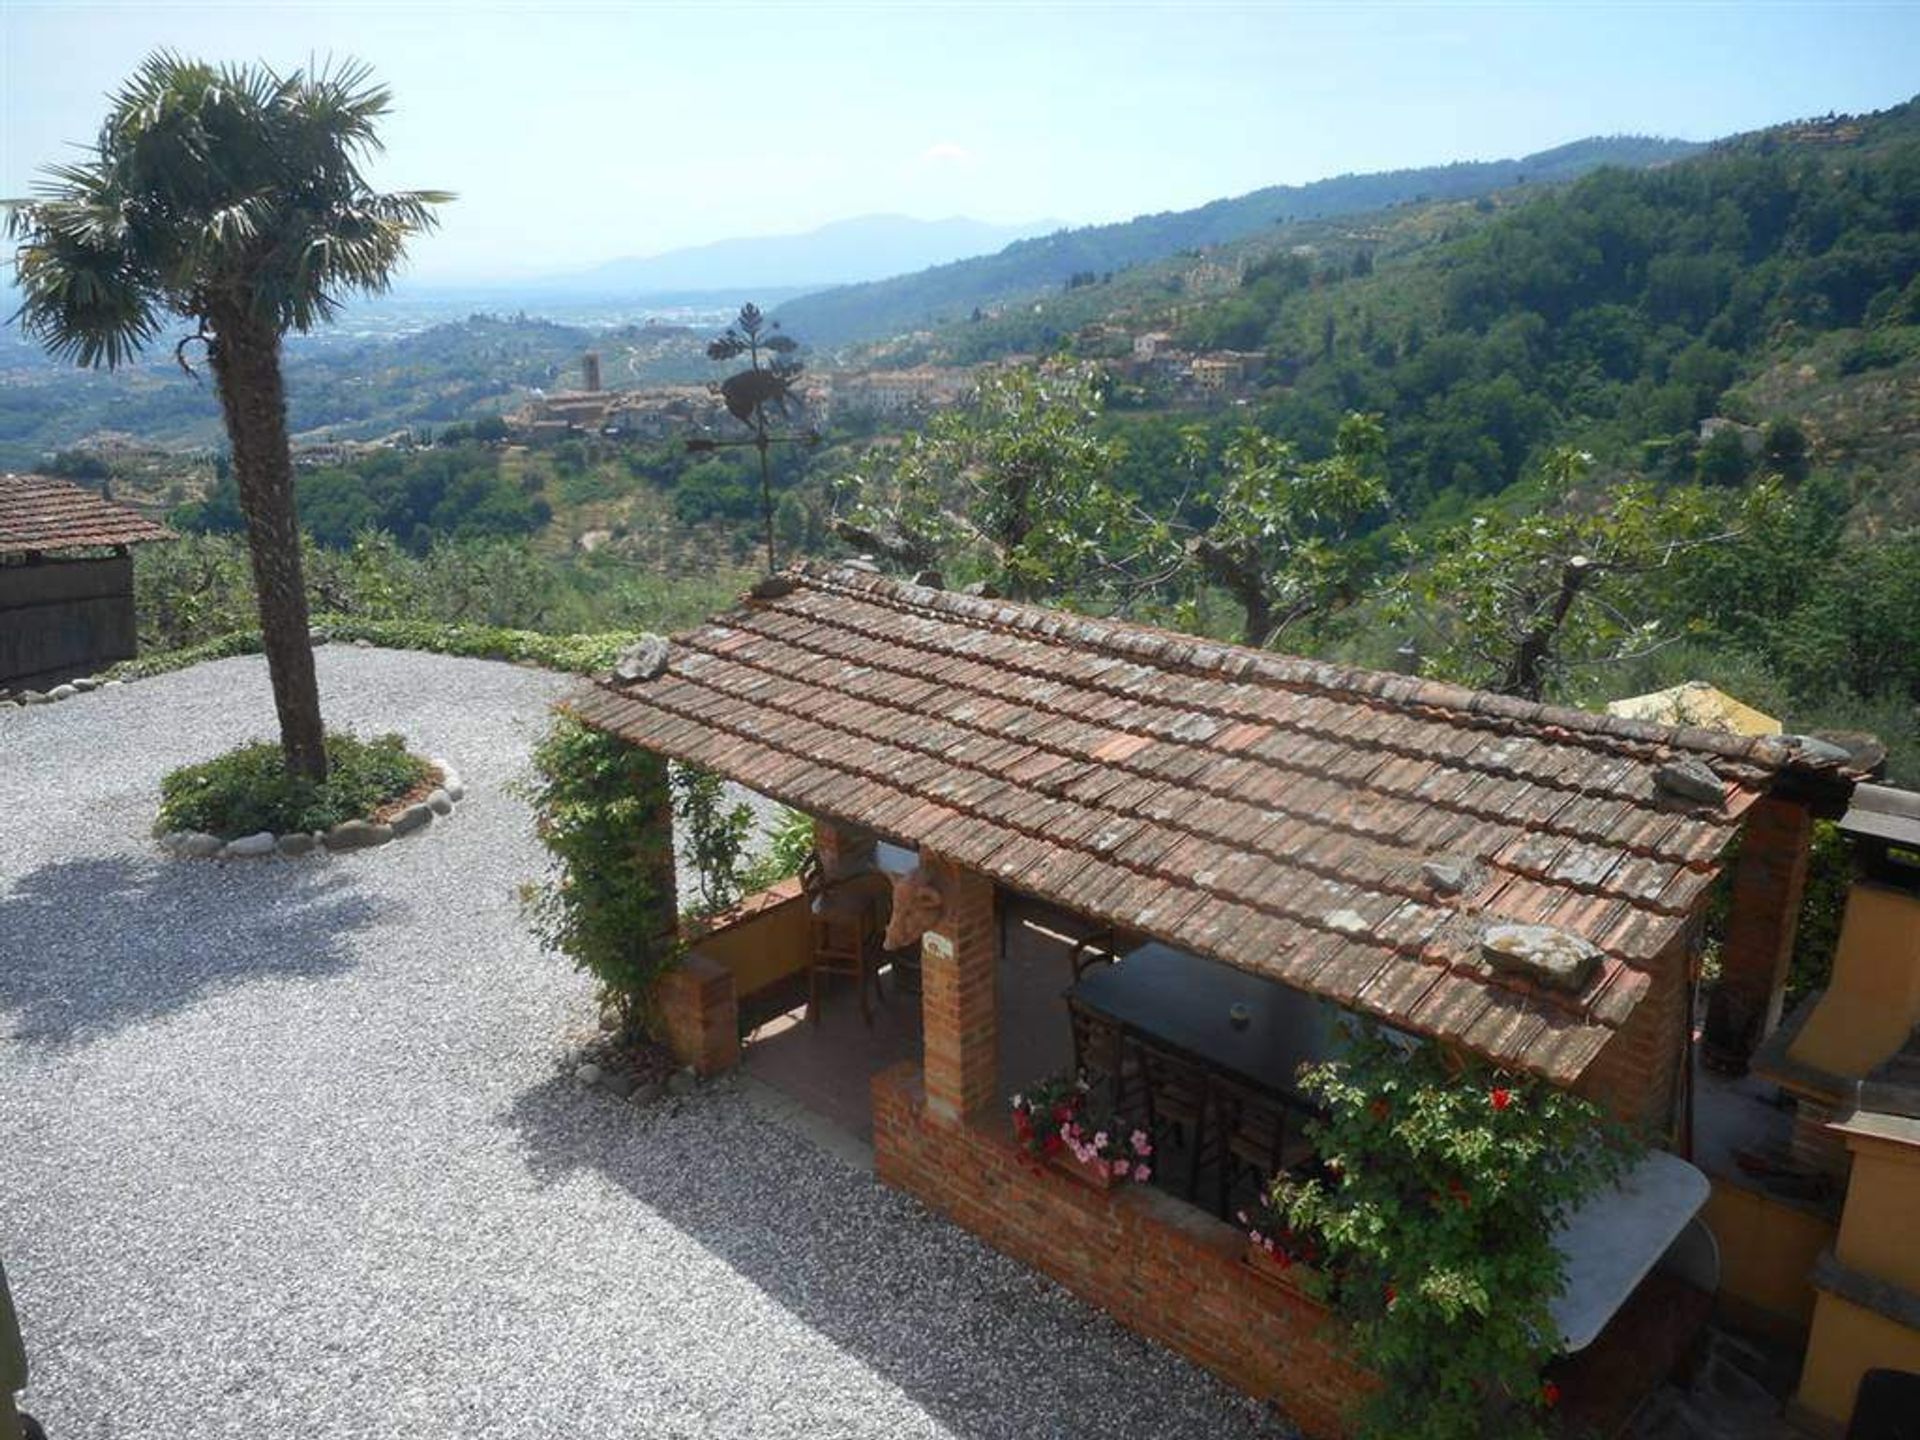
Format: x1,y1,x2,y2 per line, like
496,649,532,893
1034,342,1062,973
874,1064,1367,1440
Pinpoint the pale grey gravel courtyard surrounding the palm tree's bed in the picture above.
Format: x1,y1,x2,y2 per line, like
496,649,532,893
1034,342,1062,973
0,647,1281,1440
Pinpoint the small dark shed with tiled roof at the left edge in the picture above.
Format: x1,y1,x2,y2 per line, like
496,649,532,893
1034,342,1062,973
0,474,173,689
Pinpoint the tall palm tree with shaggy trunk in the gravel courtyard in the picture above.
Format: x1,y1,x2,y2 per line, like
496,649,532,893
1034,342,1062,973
8,52,451,780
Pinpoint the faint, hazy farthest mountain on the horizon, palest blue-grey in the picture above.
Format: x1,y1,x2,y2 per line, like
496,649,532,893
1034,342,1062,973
503,215,1060,300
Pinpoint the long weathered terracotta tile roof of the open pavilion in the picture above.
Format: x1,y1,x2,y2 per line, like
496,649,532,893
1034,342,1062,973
570,564,1837,1083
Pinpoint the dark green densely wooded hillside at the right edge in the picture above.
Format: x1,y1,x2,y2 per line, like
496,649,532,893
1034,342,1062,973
1121,102,1920,522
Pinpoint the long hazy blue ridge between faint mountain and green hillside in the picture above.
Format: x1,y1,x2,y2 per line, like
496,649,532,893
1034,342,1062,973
764,136,1699,346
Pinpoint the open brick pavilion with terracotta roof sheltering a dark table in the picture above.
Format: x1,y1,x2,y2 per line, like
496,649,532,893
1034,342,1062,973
570,564,1855,1436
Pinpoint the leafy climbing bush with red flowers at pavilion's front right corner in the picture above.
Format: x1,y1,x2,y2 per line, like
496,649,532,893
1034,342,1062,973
1271,1029,1634,1440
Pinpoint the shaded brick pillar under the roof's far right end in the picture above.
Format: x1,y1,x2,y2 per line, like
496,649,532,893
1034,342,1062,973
1701,797,1812,1075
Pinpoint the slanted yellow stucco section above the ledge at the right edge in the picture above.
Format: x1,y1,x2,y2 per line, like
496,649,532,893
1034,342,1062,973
1788,881,1920,1079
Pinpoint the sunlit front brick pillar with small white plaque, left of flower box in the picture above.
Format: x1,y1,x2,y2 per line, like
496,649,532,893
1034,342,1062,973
920,852,1000,1119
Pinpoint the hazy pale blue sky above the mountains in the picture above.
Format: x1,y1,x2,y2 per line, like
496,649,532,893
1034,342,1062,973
0,0,1920,280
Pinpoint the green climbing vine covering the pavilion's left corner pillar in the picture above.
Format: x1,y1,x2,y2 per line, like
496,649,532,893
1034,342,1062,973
522,716,680,1025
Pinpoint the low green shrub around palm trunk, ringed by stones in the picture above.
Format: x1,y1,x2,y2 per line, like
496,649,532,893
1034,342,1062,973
156,733,434,839
